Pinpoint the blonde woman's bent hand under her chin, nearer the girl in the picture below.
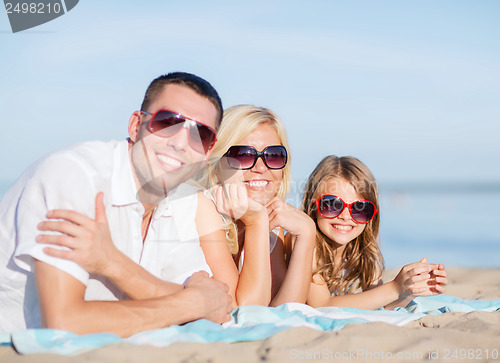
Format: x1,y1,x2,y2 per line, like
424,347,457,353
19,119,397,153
267,198,316,236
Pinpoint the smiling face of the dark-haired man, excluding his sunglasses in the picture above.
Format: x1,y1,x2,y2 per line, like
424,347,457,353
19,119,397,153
129,84,217,204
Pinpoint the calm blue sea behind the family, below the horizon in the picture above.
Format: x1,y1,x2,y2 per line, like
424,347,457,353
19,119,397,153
0,180,500,268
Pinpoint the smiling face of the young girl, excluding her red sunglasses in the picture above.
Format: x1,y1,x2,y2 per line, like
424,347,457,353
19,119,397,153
315,178,366,248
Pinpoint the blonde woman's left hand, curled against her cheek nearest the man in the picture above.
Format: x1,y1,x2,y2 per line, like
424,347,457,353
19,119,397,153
215,183,266,226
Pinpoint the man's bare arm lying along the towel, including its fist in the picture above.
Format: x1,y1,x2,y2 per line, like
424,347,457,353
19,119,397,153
35,260,232,337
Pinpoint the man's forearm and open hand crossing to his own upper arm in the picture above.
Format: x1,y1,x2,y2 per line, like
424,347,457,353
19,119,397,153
36,193,184,299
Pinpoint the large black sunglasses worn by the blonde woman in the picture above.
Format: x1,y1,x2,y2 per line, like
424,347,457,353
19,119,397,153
225,145,288,170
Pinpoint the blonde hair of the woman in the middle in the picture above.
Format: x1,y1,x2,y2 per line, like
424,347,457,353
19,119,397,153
196,105,291,254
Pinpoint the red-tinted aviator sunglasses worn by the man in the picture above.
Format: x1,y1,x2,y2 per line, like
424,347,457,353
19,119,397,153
141,110,217,154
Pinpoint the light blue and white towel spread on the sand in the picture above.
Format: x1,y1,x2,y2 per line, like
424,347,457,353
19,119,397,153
0,295,500,355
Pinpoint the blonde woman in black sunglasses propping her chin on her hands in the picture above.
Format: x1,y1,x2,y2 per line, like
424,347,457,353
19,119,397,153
197,105,315,306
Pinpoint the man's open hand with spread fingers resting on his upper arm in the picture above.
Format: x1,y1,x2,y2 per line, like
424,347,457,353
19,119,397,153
36,193,119,276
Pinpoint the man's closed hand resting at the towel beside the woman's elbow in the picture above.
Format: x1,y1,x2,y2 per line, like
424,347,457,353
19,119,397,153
186,271,233,324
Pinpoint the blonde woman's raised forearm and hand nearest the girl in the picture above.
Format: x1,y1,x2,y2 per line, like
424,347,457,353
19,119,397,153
267,198,316,306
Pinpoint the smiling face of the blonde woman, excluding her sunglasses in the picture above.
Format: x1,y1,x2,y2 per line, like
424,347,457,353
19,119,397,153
221,124,283,205
